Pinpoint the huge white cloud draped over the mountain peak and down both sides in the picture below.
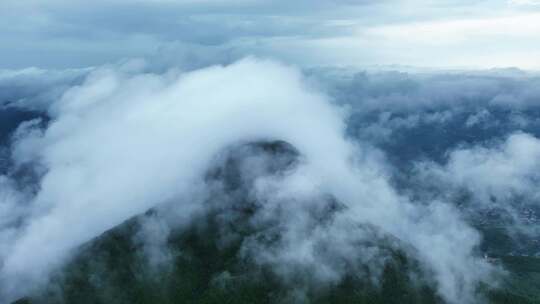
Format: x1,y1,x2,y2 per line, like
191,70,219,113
0,58,494,303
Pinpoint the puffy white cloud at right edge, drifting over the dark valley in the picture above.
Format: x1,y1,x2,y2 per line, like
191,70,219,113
418,133,540,227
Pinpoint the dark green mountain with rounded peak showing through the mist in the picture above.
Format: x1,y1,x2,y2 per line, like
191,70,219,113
11,141,540,304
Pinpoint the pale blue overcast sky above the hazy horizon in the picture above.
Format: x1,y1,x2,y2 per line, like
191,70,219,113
0,0,540,69
